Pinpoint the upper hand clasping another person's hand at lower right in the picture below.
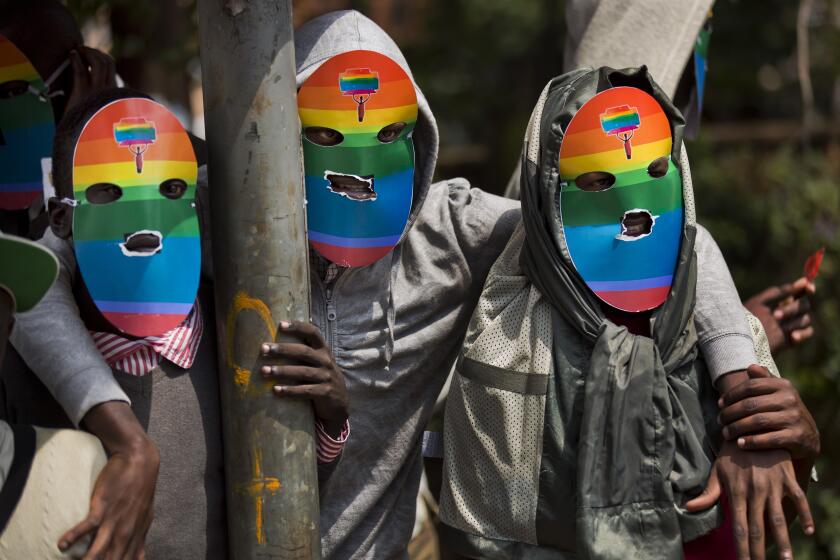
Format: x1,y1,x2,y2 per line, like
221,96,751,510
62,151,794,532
718,365,820,471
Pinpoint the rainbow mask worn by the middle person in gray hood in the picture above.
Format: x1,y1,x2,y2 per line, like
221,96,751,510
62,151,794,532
298,51,417,266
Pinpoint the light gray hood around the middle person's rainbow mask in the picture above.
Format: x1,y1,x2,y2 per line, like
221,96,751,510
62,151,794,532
295,10,438,255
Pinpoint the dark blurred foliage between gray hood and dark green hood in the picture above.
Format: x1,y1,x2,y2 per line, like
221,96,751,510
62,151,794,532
403,0,565,188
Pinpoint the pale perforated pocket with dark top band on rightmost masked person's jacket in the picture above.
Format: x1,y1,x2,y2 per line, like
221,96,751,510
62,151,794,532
440,358,550,544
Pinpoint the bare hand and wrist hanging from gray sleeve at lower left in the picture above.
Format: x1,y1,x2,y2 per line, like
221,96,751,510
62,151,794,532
58,401,160,560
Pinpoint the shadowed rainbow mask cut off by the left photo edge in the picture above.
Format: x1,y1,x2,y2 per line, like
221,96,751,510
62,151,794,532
0,35,55,210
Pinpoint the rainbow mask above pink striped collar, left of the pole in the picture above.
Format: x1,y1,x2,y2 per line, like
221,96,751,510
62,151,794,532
73,99,201,336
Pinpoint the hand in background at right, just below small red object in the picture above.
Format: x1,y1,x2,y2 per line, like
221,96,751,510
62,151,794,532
744,277,817,354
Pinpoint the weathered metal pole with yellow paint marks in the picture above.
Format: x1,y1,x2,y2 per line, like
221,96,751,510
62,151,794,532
198,0,320,560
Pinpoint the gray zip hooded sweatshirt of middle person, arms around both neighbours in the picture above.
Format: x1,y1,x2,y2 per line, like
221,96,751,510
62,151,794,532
6,11,756,560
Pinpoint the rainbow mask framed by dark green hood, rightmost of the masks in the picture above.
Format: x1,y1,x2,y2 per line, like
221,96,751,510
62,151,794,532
560,87,683,311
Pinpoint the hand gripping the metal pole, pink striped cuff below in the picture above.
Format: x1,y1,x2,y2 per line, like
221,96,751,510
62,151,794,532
260,321,349,438
